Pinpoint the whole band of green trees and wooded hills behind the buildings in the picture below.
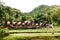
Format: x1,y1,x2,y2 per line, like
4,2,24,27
0,1,60,26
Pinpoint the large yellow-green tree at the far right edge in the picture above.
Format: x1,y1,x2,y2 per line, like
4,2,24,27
52,7,60,25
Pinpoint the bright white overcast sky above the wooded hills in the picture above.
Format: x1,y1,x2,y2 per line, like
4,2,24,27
2,0,60,12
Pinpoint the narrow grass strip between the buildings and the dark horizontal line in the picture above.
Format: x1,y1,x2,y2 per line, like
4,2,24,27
9,27,60,33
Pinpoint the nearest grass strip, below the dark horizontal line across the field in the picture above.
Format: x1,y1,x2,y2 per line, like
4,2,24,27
3,33,60,40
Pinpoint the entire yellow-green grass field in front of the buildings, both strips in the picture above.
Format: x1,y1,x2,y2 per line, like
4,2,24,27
3,27,60,40
